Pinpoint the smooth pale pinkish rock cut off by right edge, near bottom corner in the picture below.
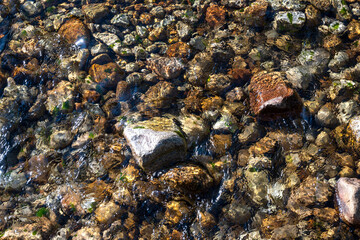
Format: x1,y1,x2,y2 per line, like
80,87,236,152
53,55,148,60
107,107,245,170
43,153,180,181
336,178,360,225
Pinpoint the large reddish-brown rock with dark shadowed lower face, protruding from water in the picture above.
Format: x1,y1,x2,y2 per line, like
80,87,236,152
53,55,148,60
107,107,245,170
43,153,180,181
249,72,302,121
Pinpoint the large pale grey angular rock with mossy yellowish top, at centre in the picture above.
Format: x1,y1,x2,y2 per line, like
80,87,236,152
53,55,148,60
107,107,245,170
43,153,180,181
123,117,186,171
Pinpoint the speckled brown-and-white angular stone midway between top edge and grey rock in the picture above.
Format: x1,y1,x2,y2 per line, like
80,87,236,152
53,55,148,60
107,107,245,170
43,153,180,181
147,57,185,79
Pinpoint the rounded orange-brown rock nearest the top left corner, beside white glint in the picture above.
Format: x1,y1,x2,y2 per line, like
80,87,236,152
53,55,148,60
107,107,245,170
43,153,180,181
59,18,90,44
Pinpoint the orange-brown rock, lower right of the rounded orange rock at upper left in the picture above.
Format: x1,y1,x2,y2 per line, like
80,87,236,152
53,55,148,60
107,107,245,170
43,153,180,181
89,62,125,88
